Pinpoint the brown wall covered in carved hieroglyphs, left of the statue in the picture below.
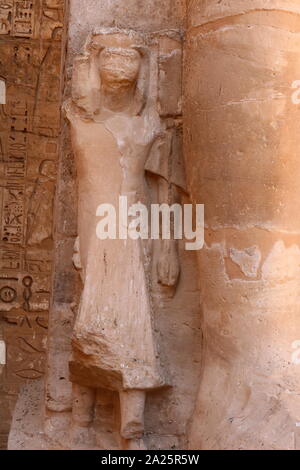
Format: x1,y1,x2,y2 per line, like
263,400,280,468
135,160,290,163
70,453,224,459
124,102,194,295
0,0,64,448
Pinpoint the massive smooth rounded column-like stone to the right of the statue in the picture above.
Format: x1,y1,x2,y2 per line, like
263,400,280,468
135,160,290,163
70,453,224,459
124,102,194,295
185,0,300,449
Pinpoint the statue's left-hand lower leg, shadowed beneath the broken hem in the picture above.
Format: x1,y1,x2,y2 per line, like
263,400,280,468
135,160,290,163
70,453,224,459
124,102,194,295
71,384,96,447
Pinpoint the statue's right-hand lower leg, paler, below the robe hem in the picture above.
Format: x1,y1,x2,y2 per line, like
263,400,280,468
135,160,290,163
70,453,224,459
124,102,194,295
120,390,146,450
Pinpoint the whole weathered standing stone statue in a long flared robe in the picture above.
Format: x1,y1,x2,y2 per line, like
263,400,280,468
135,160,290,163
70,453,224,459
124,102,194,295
65,29,184,449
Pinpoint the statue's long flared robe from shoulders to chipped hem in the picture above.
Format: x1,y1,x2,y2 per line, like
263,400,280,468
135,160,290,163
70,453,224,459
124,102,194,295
69,108,166,390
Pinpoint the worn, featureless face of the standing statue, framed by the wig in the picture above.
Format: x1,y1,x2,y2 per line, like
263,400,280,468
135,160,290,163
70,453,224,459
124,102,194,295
99,49,141,88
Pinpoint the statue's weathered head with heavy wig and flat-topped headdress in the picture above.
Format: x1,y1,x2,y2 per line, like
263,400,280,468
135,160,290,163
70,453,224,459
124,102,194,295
73,28,149,118
